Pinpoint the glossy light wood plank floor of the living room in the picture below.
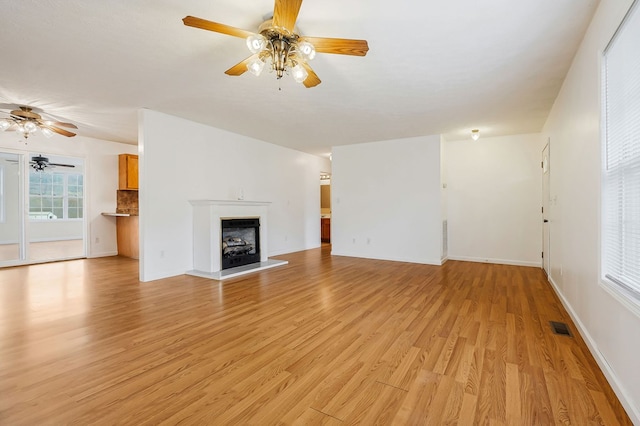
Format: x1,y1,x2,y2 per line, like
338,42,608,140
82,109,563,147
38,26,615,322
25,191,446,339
0,246,631,425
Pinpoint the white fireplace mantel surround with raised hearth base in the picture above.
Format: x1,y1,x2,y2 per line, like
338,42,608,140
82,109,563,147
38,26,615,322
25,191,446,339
187,200,287,280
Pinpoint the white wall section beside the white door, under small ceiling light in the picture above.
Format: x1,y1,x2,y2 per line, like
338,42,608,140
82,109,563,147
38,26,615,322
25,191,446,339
445,134,542,266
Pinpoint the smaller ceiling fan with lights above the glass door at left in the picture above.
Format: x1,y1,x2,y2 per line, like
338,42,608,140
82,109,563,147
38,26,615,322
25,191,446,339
0,106,78,139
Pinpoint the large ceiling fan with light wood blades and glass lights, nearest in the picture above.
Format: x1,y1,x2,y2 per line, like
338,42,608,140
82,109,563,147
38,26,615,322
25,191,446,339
182,0,369,87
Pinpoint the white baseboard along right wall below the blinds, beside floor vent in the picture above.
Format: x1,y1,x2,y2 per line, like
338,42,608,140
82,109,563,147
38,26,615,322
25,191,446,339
548,276,640,425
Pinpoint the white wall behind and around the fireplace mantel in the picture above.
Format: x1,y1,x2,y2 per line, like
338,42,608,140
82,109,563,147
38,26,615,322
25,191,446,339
139,110,329,281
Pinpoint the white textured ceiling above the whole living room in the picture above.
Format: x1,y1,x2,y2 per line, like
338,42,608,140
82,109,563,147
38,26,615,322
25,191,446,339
0,0,598,155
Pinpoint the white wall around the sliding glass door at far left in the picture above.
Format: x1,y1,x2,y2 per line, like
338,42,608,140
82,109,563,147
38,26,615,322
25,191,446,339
0,129,138,257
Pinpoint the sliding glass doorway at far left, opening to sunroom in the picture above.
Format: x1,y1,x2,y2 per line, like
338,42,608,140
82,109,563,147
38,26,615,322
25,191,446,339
0,152,86,266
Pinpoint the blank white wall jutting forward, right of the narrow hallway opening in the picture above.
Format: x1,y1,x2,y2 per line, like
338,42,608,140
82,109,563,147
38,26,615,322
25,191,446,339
331,136,442,265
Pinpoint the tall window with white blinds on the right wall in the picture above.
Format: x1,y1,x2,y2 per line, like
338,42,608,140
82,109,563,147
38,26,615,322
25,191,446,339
601,1,640,312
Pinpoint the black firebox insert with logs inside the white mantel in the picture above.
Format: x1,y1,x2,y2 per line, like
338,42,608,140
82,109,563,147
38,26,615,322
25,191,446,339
220,217,260,269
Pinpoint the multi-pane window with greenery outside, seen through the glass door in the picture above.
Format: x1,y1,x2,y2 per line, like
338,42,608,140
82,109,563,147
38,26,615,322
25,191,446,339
29,170,83,220
